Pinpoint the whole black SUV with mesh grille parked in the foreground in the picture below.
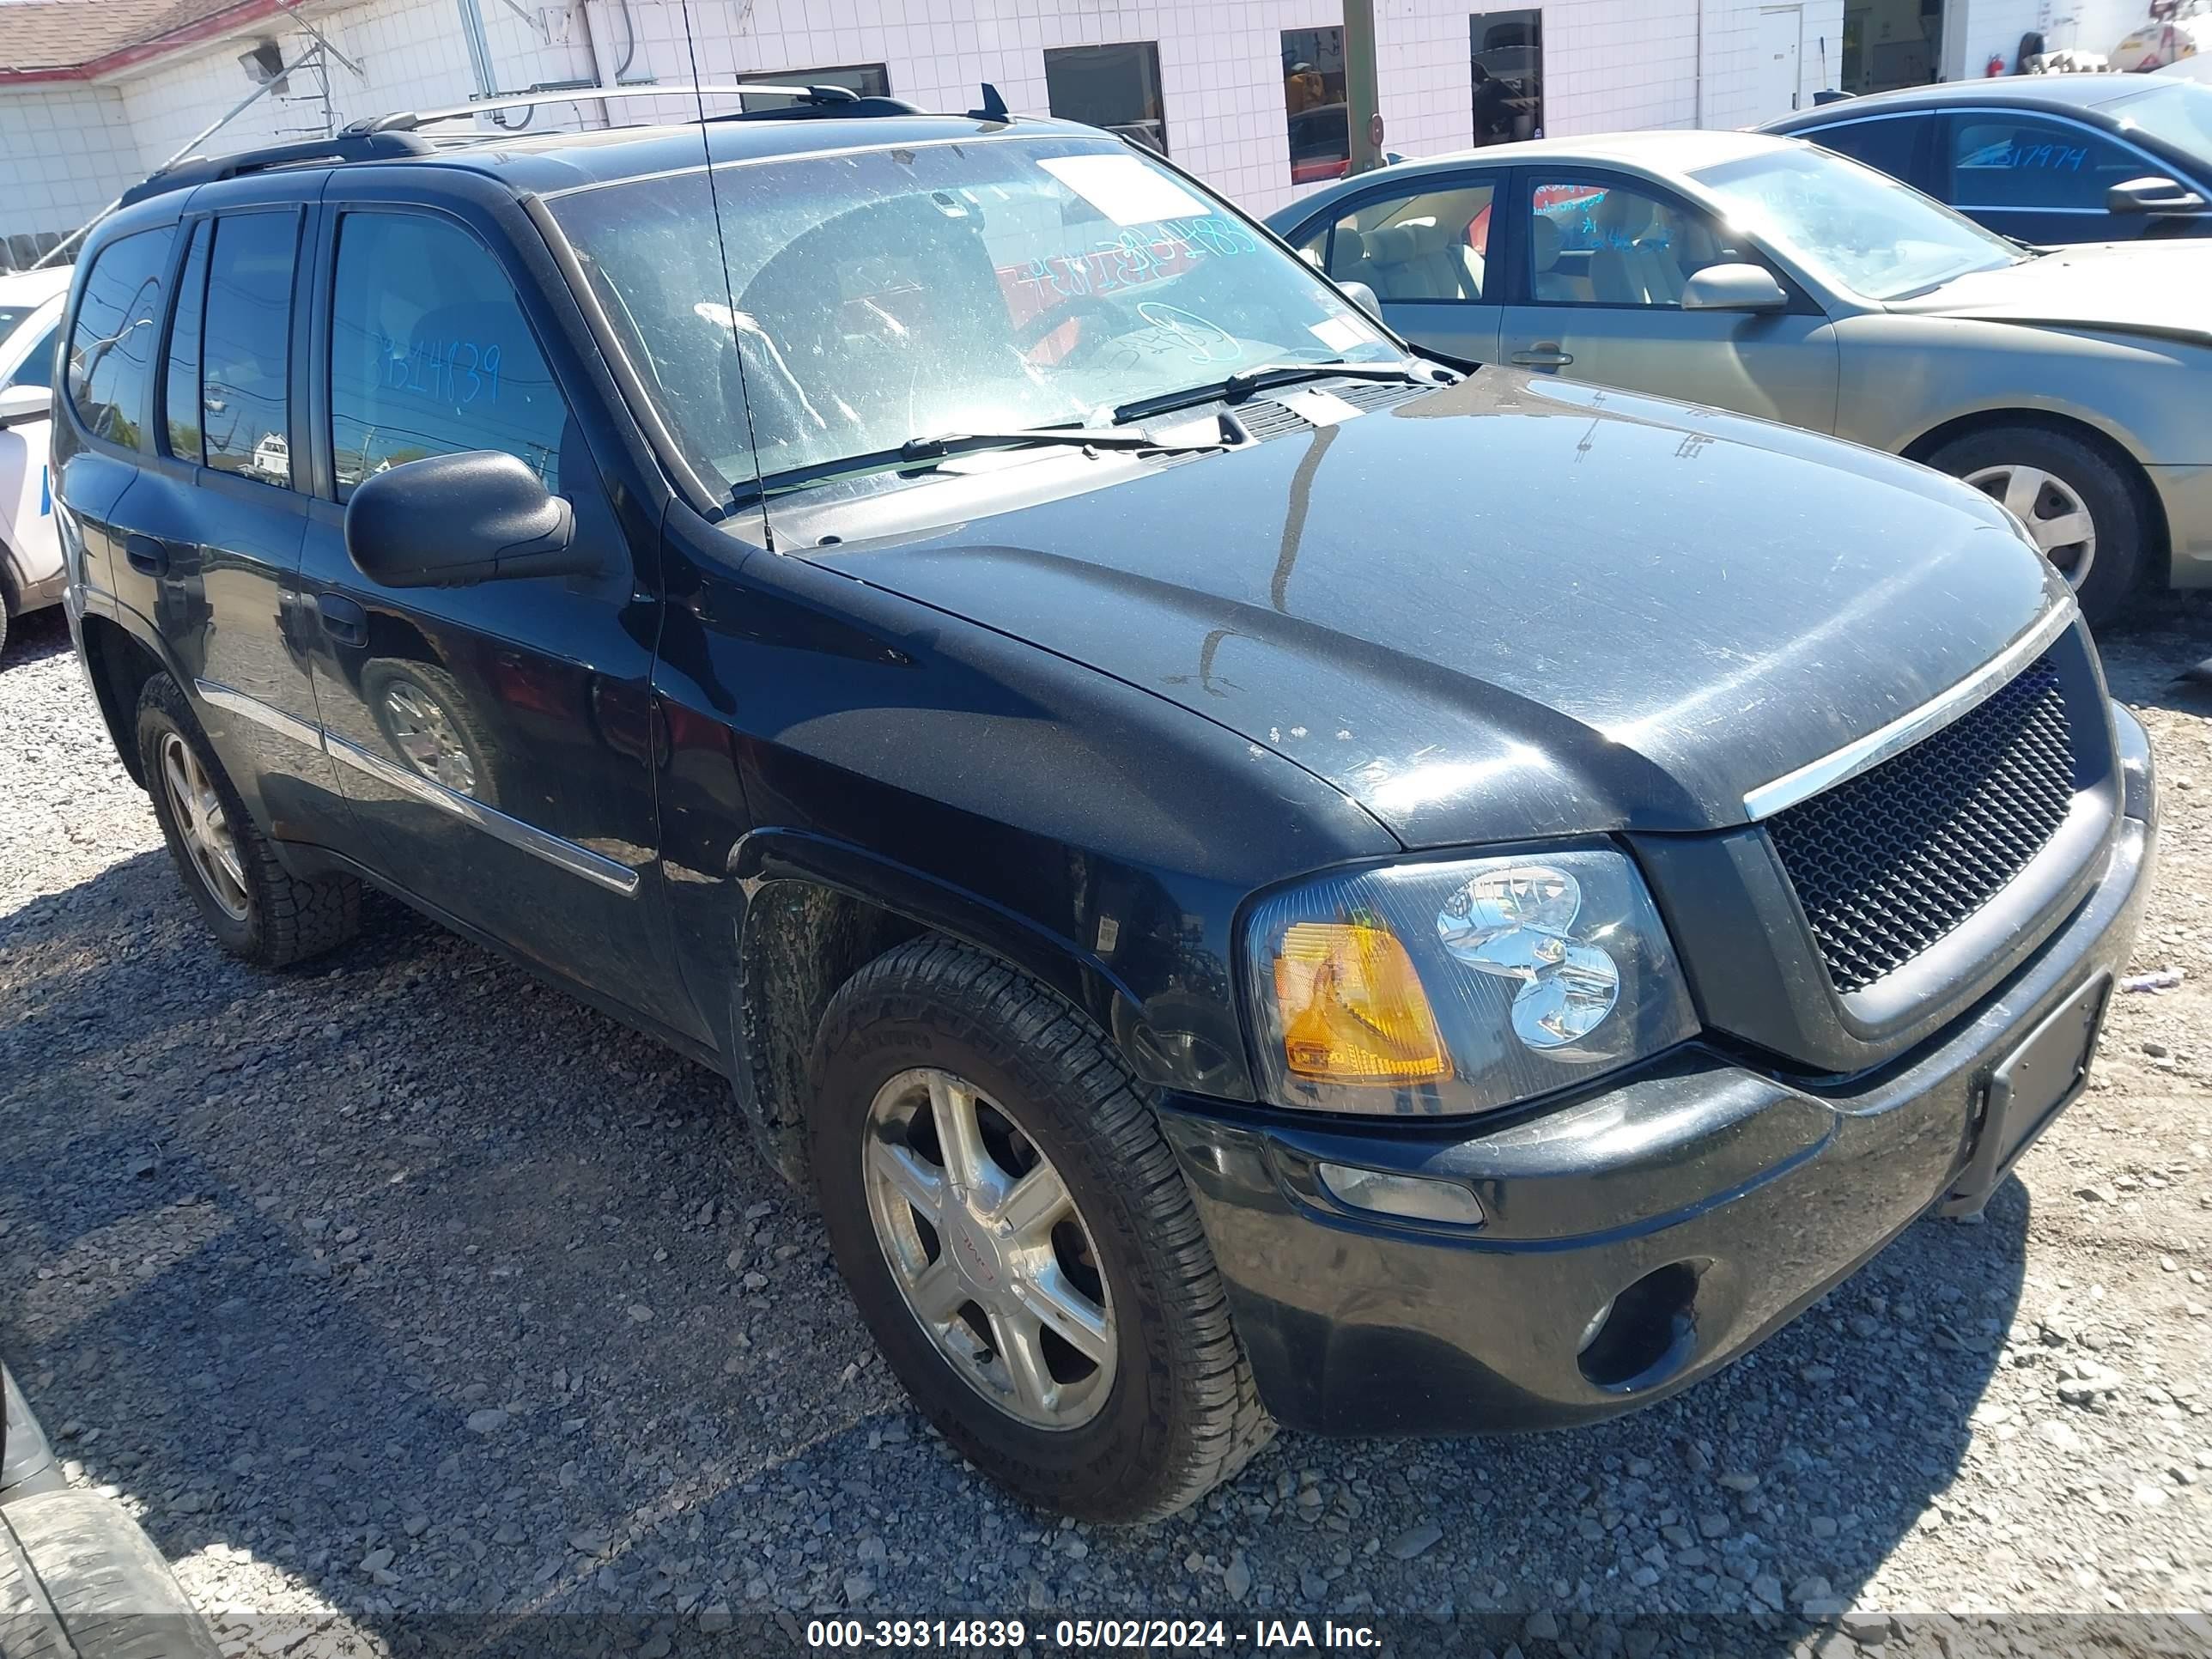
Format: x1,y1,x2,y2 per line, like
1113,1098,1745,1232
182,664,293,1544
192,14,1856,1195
55,88,2154,1520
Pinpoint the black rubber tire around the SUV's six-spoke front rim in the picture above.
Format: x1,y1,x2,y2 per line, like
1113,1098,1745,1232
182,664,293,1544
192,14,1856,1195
807,938,1274,1522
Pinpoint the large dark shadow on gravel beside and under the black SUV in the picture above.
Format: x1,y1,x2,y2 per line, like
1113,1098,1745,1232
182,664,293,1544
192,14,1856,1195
0,813,2028,1656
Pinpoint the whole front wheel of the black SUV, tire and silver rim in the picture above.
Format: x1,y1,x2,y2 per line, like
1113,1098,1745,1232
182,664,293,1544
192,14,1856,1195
807,940,1274,1522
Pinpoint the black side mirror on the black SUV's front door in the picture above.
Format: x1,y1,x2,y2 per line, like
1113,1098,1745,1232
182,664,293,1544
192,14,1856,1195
345,449,598,588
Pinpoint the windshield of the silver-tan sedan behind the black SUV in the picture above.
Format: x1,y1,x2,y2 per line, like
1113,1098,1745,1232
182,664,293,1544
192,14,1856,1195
1690,146,2028,301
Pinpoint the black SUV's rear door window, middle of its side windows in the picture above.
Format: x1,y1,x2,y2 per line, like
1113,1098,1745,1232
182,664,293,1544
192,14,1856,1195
199,212,299,489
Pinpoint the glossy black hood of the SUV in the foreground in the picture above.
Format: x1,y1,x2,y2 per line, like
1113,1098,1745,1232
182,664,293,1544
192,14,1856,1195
801,369,2063,848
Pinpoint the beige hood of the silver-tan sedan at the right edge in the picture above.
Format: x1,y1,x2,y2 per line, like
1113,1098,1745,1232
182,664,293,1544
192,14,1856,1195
1889,237,2212,345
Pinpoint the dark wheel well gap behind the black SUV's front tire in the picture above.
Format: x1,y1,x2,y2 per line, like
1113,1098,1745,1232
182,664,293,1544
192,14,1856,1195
732,880,929,1183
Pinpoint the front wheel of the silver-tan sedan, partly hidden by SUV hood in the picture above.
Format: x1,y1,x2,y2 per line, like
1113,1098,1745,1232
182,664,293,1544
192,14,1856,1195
1929,427,2143,622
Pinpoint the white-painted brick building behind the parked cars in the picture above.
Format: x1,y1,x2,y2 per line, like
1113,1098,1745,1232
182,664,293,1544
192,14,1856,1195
0,0,2143,268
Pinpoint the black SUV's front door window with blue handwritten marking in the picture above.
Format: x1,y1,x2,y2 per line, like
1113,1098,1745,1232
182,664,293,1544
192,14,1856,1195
330,212,568,500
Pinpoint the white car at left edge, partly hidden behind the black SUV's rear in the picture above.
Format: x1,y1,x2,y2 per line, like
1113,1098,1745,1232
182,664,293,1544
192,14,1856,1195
0,265,69,650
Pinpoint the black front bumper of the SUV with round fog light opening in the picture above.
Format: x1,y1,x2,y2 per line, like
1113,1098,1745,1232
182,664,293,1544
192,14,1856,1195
1161,710,2157,1433
